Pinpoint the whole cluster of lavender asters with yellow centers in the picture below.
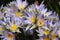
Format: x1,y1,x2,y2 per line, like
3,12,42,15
0,0,60,40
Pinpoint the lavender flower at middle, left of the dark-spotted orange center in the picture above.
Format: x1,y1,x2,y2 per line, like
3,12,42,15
23,12,36,30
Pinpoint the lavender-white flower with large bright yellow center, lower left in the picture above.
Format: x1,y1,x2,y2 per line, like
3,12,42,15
5,19,21,32
